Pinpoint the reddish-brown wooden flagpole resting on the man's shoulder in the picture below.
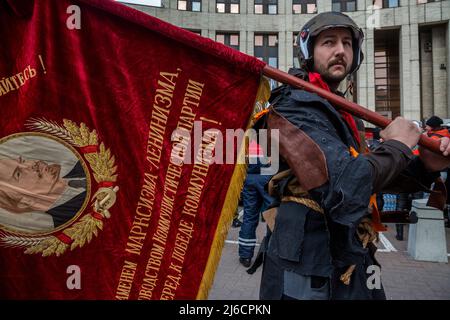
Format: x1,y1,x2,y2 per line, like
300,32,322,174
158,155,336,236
263,65,442,155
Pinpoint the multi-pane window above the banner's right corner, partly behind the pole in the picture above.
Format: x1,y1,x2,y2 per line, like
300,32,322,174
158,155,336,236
254,33,278,89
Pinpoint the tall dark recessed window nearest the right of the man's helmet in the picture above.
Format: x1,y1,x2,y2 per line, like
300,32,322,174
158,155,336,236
374,30,400,119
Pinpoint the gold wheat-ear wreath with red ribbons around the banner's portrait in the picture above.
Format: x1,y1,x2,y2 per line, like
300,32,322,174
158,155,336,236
0,118,119,257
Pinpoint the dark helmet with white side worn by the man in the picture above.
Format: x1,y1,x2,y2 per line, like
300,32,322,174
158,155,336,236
297,12,364,74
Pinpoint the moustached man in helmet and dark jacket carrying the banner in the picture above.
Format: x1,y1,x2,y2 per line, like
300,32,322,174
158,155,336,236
260,12,450,299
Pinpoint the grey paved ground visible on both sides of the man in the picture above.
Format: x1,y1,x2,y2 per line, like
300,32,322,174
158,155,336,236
209,212,450,300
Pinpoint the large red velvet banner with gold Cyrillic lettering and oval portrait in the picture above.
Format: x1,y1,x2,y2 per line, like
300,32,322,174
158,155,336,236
0,0,264,299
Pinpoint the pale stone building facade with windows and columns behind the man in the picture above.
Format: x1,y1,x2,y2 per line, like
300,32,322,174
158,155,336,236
124,0,450,119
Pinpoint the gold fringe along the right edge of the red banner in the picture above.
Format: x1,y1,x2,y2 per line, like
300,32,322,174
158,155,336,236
196,77,270,300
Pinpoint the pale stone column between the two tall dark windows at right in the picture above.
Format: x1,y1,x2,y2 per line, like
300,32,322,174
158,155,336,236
399,24,420,120
